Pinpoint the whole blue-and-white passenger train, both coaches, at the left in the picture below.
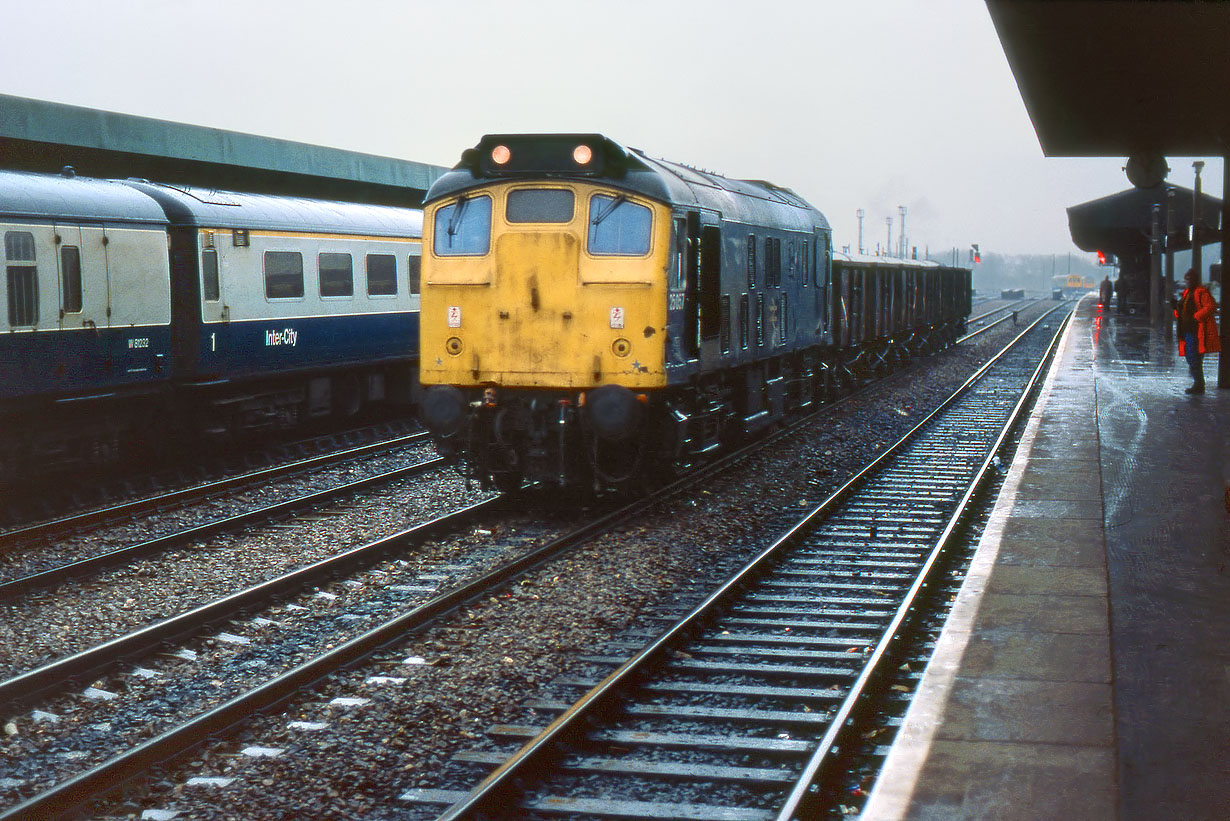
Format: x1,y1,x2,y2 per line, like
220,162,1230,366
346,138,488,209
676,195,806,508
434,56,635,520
0,170,422,483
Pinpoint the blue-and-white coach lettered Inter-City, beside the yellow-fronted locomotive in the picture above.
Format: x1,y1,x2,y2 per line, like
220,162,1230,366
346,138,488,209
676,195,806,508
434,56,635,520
129,181,422,433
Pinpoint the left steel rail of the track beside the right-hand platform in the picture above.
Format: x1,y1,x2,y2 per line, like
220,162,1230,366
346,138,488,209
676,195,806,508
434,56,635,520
438,309,1066,821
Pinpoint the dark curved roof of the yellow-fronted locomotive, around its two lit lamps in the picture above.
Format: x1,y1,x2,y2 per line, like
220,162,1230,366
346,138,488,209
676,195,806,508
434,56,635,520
423,134,829,231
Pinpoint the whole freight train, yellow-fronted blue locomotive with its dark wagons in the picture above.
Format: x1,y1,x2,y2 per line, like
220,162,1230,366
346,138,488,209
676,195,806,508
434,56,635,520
421,134,972,489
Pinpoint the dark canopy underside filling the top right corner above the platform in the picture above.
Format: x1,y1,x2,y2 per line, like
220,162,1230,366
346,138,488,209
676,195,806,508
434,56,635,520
986,0,1230,156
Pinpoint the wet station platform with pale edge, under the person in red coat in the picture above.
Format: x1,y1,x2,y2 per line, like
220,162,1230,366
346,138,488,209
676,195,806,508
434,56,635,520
861,297,1230,821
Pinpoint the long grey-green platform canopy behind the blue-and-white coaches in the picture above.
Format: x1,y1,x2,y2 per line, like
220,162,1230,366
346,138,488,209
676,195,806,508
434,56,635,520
0,95,446,206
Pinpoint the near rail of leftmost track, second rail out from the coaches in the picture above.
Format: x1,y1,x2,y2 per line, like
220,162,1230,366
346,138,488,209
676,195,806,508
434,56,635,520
0,457,444,602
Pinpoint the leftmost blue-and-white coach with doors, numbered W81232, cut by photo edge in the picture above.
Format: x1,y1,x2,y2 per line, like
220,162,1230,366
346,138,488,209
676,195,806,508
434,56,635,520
0,171,171,484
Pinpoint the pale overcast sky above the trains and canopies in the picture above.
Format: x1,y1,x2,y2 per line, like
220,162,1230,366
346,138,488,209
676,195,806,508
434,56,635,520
0,0,1221,254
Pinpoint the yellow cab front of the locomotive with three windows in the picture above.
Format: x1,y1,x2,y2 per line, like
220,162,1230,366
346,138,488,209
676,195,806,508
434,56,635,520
421,181,670,390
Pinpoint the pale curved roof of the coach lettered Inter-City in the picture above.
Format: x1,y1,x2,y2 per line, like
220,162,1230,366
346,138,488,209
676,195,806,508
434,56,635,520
125,180,423,236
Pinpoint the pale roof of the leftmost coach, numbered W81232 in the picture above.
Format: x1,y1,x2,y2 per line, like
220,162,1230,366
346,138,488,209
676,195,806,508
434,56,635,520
0,171,167,225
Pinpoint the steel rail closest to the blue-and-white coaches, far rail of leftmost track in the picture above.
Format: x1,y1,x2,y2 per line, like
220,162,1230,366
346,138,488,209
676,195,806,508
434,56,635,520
0,431,429,548
